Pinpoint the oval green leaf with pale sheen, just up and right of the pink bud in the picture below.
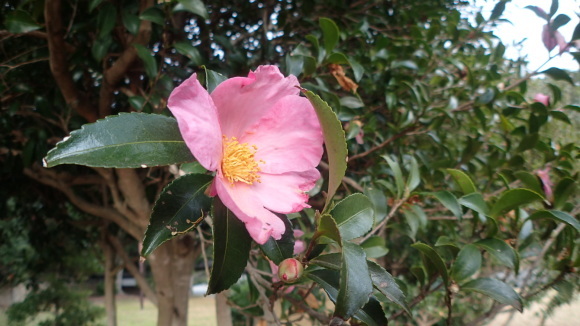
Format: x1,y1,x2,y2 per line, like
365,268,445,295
330,193,374,240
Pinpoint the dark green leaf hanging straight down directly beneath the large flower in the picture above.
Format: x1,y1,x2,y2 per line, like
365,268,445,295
206,197,252,295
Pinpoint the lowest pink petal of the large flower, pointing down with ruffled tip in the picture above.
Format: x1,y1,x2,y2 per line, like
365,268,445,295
215,175,286,244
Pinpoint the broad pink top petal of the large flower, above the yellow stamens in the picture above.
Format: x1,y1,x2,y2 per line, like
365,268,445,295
211,66,299,138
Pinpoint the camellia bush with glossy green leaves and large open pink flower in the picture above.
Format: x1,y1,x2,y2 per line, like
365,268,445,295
3,0,580,325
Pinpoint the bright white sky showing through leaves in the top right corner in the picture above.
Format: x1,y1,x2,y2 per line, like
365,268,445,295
475,0,580,70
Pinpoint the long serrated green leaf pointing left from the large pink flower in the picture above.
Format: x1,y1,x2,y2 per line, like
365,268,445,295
44,113,194,168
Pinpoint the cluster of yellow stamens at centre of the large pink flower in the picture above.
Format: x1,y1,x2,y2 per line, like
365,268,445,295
222,135,264,185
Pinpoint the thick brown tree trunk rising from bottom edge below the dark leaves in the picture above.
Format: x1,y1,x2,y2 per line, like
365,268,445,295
148,234,200,326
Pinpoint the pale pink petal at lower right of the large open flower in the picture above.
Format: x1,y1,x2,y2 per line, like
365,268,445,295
251,168,320,214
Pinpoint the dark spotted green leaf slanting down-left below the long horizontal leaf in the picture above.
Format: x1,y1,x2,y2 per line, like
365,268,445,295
141,174,213,257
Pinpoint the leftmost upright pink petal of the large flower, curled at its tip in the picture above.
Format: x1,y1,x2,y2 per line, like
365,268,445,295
167,74,222,171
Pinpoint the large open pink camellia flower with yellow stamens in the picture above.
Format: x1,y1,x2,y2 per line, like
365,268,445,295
167,66,323,244
